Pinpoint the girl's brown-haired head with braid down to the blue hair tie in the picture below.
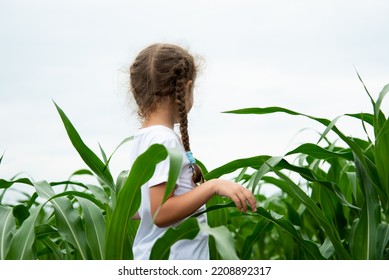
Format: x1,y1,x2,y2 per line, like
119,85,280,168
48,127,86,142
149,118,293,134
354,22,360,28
130,44,203,183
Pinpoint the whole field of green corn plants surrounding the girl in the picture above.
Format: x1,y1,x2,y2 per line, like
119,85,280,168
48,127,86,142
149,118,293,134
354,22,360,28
0,76,389,260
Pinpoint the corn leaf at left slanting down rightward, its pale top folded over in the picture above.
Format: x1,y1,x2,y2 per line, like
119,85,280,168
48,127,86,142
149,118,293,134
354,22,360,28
34,181,89,260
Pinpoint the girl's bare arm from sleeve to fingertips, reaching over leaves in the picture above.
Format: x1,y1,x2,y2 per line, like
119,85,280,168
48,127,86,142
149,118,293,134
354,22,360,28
150,179,256,227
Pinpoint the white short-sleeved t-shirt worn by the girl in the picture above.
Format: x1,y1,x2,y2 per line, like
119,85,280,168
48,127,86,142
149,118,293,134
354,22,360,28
130,125,209,260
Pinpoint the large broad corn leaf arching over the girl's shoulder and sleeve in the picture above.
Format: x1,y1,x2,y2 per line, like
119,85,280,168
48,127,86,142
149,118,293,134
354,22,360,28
105,144,182,260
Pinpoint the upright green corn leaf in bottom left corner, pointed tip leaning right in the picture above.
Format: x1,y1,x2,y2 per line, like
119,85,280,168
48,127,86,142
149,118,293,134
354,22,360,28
6,204,43,260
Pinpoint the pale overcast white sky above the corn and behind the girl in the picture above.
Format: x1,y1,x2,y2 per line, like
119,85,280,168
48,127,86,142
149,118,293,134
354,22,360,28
0,0,389,198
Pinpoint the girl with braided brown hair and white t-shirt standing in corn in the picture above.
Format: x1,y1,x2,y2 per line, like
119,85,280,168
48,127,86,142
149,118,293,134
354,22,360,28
130,44,256,259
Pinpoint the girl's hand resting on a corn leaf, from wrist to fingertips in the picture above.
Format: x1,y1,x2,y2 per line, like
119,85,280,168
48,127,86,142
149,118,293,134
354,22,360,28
214,179,257,212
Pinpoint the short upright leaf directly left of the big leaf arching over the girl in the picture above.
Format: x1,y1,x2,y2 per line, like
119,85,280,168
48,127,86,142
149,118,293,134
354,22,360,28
77,197,105,260
